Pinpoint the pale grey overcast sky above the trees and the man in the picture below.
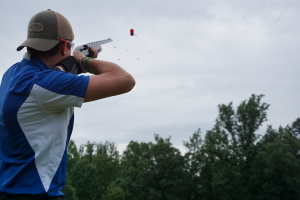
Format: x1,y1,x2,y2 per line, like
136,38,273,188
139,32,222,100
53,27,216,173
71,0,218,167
0,0,300,153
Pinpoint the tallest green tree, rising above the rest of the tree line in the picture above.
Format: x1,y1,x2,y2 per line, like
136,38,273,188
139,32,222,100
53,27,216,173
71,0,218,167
184,95,269,200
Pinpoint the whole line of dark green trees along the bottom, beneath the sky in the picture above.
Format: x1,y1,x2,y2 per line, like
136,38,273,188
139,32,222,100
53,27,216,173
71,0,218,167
62,94,300,200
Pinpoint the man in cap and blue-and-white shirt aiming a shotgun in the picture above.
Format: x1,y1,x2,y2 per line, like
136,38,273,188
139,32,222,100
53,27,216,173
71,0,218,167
0,9,135,200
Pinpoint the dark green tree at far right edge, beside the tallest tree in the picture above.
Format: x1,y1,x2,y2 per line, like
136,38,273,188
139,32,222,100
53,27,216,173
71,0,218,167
250,122,300,200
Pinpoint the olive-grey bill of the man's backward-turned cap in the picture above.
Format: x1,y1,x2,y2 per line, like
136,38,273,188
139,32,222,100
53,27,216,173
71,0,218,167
17,38,59,51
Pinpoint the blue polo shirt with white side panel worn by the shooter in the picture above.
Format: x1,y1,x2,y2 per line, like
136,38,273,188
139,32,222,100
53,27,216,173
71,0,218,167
0,53,89,198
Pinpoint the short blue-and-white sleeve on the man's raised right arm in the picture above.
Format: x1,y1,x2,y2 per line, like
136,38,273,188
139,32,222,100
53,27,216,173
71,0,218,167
33,71,89,112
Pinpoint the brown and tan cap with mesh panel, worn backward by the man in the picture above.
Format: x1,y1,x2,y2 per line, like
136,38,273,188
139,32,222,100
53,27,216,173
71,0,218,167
17,9,74,51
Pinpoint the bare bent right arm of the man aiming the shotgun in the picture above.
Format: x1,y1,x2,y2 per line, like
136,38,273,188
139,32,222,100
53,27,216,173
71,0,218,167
73,48,135,102
